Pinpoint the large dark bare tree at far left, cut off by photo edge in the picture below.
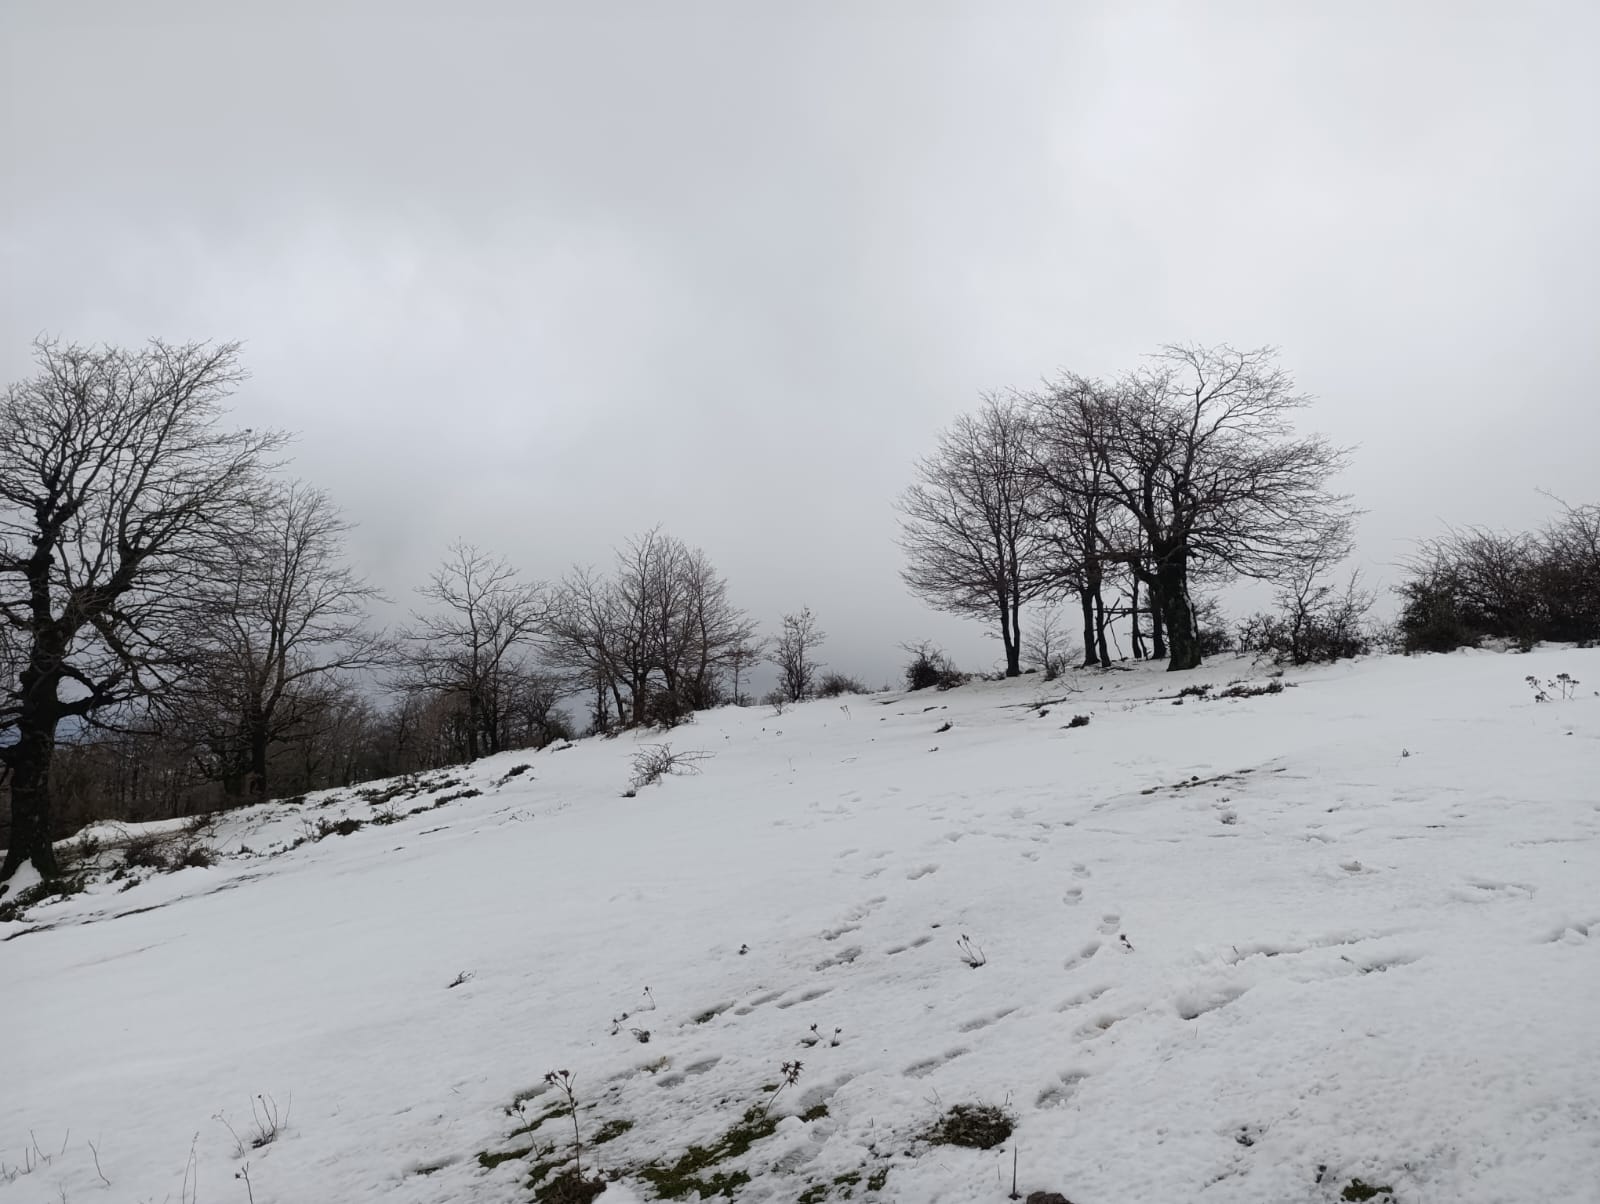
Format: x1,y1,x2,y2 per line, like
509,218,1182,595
0,341,282,881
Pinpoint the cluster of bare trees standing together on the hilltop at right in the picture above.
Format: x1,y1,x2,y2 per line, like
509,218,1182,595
899,346,1352,676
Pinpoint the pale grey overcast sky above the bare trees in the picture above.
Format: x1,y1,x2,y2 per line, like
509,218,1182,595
0,0,1600,682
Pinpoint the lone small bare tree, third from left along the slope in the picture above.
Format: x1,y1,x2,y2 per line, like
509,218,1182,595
402,543,547,759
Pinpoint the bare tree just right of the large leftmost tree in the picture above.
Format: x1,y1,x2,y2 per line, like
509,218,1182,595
178,482,389,799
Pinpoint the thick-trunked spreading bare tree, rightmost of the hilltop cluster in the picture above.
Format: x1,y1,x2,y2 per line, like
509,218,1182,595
1091,346,1350,669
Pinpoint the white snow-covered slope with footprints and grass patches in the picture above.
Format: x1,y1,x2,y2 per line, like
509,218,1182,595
0,648,1600,1204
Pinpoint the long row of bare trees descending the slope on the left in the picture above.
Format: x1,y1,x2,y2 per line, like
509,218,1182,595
0,341,793,884
